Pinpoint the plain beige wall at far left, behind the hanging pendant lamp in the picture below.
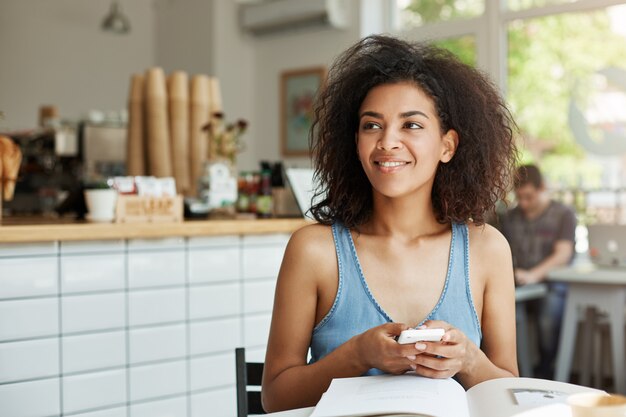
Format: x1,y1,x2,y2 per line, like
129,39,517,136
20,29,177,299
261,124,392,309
0,0,155,130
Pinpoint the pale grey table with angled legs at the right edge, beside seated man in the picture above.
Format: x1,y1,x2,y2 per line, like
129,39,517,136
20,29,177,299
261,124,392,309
548,264,626,394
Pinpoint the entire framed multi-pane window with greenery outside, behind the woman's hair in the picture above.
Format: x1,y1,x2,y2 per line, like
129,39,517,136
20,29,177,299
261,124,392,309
388,0,626,189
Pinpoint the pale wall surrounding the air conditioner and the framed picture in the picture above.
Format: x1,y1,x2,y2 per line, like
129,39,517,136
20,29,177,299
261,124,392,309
205,0,360,170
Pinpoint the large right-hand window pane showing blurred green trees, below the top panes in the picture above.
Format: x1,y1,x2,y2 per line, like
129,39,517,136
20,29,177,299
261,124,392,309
507,6,626,188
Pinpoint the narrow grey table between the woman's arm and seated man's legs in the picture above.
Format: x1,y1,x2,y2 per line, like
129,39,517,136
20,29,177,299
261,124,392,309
515,283,548,377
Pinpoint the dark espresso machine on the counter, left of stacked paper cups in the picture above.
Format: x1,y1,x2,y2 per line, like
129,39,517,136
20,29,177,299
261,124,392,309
3,122,126,218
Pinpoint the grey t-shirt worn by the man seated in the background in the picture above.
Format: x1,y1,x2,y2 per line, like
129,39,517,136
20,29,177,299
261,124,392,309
501,201,576,269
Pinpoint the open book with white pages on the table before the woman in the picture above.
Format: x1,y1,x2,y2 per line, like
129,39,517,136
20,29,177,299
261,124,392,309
311,374,596,417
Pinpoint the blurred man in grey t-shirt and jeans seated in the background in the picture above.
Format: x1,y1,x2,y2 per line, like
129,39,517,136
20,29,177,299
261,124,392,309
501,165,576,379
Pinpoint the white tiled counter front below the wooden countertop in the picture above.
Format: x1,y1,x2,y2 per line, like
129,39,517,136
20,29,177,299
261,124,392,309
0,233,289,417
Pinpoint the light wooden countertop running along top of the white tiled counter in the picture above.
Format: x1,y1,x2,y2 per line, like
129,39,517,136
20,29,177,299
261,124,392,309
0,218,309,243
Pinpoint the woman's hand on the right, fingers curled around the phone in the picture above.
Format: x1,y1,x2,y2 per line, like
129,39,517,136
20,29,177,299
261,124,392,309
410,320,478,378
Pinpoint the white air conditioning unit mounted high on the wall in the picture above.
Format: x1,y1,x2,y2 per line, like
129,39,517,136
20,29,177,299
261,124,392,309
240,0,348,35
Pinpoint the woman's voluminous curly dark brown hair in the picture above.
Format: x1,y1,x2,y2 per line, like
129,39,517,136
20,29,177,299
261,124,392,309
309,35,517,228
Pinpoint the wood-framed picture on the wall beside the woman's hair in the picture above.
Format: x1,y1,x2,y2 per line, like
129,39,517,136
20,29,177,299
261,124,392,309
280,67,326,156
